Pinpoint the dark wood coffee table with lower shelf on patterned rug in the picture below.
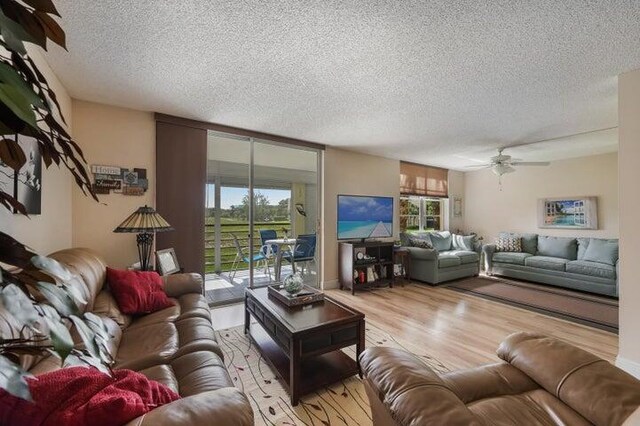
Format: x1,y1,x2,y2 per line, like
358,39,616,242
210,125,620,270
244,288,365,406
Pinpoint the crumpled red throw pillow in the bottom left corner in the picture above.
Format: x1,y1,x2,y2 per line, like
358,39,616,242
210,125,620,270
0,367,180,426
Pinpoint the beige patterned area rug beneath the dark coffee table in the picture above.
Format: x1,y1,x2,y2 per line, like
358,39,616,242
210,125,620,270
216,322,449,426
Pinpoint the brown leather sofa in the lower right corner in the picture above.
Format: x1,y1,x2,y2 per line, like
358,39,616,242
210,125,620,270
360,333,640,426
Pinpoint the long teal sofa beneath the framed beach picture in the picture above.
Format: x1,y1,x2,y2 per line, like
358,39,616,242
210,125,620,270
482,232,619,297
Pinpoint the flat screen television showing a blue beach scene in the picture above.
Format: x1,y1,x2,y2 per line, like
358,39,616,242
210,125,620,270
338,195,393,240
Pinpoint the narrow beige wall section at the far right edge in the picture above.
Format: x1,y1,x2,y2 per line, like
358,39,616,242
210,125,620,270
618,70,640,378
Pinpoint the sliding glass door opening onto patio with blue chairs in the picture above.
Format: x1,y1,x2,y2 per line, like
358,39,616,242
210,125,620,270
205,132,320,303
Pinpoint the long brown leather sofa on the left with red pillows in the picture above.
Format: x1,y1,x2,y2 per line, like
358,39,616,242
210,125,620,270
0,249,253,426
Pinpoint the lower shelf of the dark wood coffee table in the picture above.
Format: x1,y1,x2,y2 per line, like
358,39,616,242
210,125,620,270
249,322,359,406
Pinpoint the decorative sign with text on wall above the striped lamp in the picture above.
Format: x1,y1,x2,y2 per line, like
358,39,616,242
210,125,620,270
91,165,149,195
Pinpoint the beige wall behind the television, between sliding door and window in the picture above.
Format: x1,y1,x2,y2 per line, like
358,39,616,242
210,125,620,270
320,147,400,288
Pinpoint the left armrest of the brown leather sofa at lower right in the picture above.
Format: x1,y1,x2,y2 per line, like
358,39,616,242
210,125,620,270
360,347,480,426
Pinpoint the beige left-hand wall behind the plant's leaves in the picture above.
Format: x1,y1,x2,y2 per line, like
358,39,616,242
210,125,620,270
0,49,73,254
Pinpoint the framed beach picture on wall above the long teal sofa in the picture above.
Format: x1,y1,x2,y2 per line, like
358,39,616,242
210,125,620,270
538,197,598,229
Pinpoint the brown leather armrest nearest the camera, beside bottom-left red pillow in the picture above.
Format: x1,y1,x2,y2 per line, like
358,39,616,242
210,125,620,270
125,388,254,426
